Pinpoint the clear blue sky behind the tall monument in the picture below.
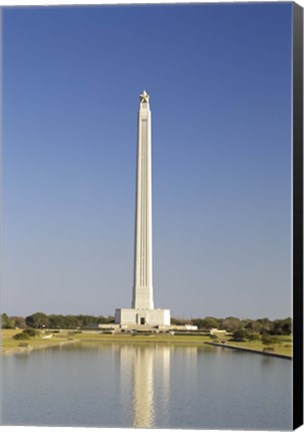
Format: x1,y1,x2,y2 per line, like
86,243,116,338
1,3,292,318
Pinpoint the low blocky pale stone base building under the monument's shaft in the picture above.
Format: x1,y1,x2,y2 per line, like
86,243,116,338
115,308,171,326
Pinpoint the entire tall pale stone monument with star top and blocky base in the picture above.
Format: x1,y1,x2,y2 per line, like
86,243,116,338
115,91,170,325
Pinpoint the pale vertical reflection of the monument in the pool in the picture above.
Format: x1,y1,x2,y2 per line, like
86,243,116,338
120,344,172,428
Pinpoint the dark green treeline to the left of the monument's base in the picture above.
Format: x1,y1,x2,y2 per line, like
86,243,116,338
1,312,114,329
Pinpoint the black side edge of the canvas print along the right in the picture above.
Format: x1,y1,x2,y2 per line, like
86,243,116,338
292,3,303,429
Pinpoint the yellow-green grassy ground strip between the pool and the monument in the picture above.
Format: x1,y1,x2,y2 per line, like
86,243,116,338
1,329,292,357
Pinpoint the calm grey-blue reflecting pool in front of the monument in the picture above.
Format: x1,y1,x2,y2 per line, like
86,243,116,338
2,343,292,430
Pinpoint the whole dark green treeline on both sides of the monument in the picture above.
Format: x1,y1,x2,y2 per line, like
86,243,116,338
1,312,292,337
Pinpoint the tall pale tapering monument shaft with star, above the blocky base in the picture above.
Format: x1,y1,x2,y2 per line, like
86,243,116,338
132,91,154,309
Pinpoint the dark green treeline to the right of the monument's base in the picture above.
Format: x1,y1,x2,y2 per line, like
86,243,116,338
171,317,292,335
